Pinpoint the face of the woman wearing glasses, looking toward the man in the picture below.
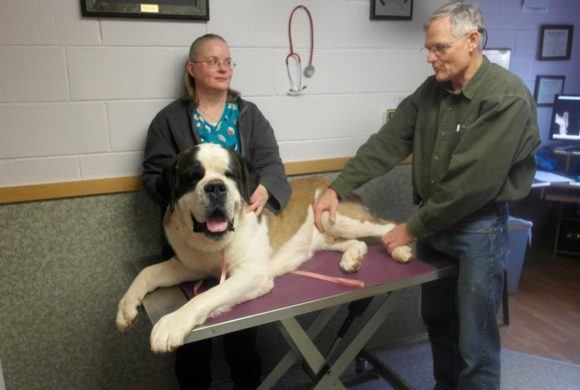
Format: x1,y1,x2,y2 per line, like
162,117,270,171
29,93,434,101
186,39,233,94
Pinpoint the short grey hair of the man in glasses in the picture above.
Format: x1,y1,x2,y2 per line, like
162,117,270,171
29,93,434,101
423,1,487,51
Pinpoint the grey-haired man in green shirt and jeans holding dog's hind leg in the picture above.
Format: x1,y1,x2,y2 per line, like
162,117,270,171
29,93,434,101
314,1,540,389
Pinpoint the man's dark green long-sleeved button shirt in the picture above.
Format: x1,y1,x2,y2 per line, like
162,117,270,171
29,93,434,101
331,57,540,238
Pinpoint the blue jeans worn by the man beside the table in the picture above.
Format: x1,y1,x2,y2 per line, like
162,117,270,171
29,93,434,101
417,205,508,389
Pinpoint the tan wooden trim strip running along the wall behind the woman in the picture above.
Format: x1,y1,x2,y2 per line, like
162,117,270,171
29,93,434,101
0,156,411,204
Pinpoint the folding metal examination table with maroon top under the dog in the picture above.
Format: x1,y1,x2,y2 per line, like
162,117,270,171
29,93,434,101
137,246,456,389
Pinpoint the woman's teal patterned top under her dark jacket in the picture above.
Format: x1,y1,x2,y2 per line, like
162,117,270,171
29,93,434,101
193,102,240,153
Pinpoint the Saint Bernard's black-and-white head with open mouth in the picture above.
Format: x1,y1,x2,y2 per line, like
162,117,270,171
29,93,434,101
163,144,259,240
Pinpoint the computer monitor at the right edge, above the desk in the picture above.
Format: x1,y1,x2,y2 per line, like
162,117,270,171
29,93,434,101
550,95,580,149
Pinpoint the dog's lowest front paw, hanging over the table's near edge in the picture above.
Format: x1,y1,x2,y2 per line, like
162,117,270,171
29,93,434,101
150,311,201,353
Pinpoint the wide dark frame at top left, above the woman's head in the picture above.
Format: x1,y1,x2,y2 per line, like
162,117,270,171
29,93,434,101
81,0,209,20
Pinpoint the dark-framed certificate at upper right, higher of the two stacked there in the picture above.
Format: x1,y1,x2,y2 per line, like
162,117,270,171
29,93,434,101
538,24,574,61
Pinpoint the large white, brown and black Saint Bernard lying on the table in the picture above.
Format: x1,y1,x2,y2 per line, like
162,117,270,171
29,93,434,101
116,144,411,353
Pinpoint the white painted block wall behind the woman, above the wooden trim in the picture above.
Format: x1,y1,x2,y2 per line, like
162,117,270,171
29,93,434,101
0,0,446,187
